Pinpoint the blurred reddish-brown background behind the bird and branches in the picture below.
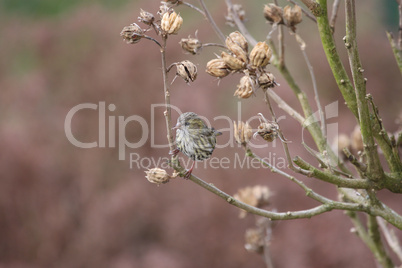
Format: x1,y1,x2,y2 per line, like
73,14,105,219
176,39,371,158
0,0,402,268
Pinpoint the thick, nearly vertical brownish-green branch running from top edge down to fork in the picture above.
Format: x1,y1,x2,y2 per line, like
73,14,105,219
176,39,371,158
345,0,384,181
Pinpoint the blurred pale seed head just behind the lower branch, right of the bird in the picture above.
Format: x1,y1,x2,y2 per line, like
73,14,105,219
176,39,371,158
233,185,271,218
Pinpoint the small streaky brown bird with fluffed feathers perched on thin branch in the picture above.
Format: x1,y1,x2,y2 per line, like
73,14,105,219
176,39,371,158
173,112,222,179
